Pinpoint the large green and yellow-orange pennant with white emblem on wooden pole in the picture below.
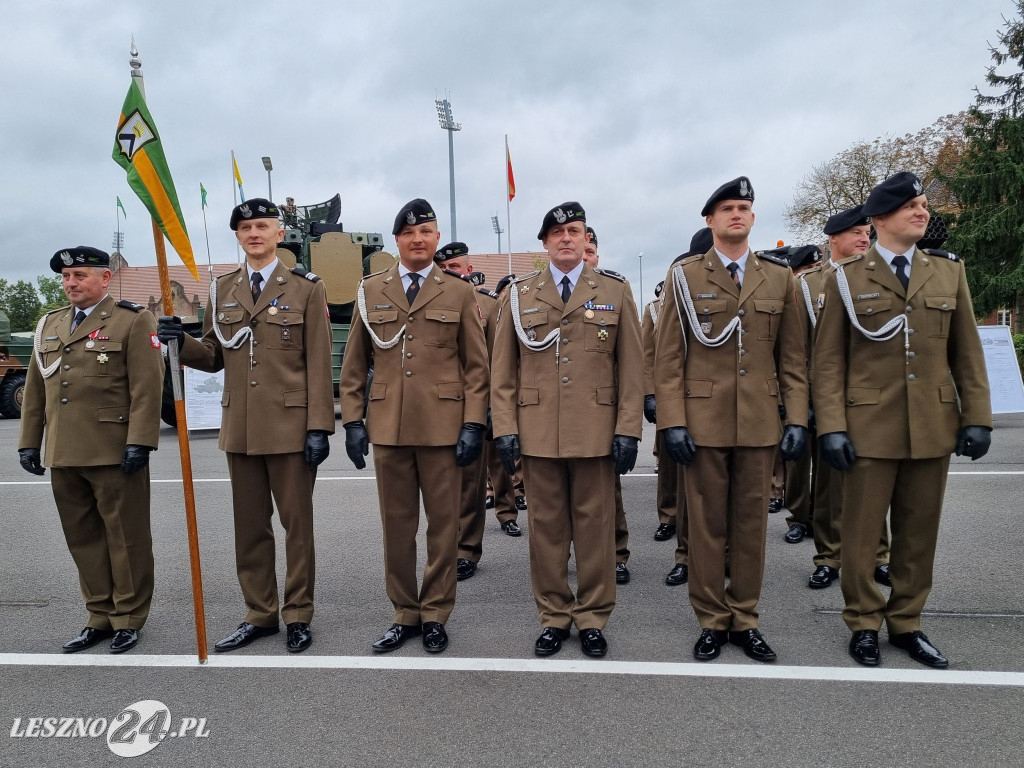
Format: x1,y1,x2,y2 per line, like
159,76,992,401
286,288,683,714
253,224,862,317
113,81,199,280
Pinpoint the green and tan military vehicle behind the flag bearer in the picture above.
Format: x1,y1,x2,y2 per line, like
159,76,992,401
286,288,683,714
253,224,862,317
162,195,395,426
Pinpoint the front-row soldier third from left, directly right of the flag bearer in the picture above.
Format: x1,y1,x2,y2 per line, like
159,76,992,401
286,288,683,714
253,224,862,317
341,199,487,653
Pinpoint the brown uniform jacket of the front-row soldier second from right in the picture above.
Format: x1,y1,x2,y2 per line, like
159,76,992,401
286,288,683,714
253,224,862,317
654,248,808,447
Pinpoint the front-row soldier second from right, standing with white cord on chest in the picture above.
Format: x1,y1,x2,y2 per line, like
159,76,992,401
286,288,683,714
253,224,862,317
654,176,807,662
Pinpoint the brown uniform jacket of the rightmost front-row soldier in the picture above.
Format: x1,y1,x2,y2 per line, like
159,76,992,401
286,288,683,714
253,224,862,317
814,246,992,459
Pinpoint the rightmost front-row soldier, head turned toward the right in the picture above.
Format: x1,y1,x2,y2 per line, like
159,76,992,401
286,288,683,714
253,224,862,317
814,172,992,669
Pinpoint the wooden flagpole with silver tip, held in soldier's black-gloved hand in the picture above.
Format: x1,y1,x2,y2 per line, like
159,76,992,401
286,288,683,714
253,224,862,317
129,37,207,664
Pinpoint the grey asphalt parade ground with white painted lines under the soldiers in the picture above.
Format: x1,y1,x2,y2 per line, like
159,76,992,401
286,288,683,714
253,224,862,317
0,415,1024,768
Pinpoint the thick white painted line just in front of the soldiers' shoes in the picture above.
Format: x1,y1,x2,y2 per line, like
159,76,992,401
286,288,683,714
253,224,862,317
0,653,1024,688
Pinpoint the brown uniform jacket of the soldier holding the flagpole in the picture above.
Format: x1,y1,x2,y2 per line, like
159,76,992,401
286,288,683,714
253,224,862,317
181,262,335,456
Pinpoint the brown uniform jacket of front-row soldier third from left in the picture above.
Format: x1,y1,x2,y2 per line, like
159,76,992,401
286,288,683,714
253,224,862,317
341,262,487,445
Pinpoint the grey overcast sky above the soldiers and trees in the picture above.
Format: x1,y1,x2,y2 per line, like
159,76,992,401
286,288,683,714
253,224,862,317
0,0,1014,307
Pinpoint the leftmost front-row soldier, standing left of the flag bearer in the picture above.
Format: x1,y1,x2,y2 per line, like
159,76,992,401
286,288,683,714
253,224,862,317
17,246,164,653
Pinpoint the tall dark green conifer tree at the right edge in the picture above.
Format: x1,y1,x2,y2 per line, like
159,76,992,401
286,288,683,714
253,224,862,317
939,0,1024,317
